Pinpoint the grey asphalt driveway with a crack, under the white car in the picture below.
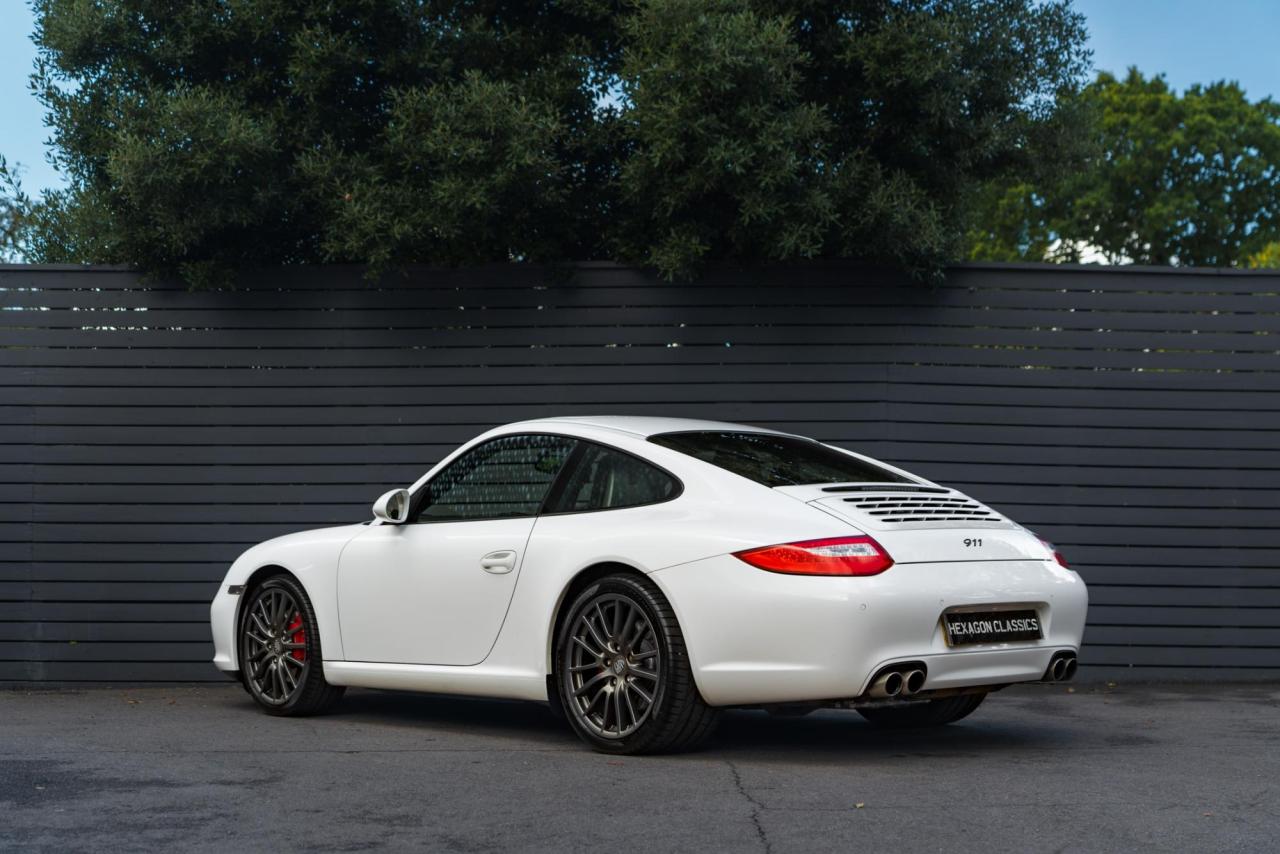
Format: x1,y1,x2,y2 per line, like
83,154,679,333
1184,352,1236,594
0,685,1280,854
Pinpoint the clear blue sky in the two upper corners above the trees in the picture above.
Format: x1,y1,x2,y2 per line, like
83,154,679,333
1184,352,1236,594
0,0,1280,195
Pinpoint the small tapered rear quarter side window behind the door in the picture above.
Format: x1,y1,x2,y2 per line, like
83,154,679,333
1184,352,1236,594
548,442,680,513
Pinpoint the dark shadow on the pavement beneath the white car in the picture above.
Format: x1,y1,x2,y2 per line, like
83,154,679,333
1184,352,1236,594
330,690,1080,763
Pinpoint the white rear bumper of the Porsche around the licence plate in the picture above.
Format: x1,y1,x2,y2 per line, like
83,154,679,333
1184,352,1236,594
650,556,1088,705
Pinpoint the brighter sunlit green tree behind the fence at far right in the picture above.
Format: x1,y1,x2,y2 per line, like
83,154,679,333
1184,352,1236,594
970,69,1280,266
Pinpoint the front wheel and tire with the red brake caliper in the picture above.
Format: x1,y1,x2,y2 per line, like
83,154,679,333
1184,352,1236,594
239,575,347,717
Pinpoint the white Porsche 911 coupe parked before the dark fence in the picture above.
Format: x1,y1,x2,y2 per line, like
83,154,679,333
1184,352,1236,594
211,416,1087,753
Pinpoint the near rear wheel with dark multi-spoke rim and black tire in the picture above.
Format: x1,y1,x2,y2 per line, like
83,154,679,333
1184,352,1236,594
554,574,719,754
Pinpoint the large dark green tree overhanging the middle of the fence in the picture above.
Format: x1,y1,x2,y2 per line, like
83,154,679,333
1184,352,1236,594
24,0,1088,283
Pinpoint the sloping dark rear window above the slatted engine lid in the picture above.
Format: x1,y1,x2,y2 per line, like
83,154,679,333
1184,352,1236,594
649,431,913,487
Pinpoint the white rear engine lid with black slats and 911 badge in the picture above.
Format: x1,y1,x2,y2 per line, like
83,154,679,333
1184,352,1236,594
778,484,1052,563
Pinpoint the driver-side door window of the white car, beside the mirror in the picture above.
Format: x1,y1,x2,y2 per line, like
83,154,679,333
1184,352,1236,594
415,435,575,522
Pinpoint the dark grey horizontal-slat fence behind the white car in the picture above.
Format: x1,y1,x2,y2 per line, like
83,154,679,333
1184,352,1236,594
0,265,1280,681
